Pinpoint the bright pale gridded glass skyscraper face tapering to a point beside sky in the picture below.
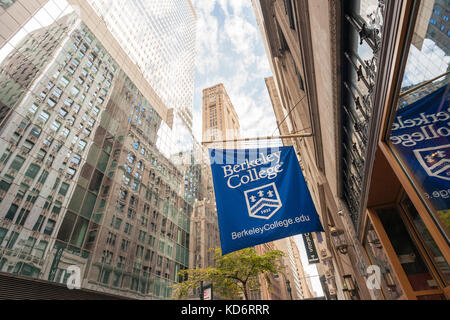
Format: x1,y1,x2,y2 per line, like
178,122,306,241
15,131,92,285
87,0,197,129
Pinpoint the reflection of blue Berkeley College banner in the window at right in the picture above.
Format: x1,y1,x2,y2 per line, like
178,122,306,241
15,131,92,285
390,85,450,216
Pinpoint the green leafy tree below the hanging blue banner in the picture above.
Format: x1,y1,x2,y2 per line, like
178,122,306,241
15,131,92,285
173,248,284,300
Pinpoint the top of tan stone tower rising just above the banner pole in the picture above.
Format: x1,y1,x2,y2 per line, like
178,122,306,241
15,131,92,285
202,83,240,148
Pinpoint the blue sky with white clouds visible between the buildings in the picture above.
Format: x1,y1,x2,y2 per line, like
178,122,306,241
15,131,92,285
192,0,323,295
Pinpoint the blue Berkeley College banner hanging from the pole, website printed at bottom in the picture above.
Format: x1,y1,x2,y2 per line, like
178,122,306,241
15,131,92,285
209,147,323,254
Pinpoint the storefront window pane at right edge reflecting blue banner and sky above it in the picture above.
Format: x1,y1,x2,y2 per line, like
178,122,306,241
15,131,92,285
389,0,450,239
